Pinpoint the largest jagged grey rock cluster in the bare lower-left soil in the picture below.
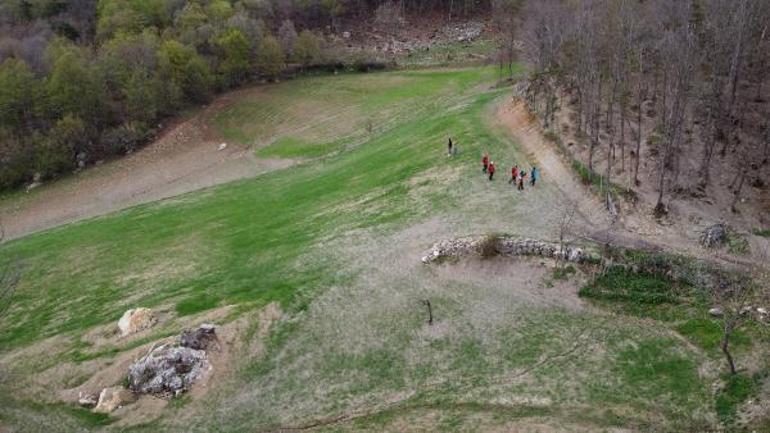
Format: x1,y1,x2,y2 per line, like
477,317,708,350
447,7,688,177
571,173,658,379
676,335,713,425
128,345,211,398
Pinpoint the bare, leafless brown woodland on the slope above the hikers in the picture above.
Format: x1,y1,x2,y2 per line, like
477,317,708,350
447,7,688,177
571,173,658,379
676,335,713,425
523,0,770,215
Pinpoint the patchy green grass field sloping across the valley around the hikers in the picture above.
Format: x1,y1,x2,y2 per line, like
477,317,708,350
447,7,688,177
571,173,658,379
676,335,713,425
0,68,756,432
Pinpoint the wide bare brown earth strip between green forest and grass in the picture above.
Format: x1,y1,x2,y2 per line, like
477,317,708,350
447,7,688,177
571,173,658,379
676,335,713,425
0,95,294,239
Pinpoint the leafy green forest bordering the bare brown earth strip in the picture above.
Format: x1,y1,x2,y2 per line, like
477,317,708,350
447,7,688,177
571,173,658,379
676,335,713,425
0,0,498,190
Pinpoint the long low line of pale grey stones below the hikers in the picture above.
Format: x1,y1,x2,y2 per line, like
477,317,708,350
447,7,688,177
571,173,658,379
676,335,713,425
422,236,592,263
